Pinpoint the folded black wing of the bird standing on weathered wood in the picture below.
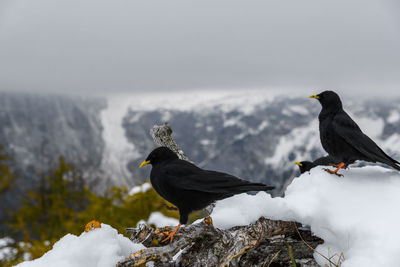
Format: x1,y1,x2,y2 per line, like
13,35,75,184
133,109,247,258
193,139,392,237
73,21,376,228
163,163,273,194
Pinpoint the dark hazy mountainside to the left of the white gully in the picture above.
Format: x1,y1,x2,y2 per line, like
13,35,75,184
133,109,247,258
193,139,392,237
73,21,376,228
0,93,106,191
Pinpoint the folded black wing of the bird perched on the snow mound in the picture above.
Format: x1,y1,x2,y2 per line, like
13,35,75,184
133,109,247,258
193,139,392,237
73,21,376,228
332,112,398,163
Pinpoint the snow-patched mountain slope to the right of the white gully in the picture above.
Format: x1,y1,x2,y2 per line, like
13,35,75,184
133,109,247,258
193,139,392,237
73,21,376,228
118,91,400,194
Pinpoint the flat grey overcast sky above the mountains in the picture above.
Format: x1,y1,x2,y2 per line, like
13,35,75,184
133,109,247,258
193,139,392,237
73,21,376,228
0,0,400,94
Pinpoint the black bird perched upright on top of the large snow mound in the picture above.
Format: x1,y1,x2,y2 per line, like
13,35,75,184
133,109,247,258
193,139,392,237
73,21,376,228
310,91,400,175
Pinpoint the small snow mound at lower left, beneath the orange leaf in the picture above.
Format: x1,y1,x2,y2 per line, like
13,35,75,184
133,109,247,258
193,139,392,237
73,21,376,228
17,224,145,267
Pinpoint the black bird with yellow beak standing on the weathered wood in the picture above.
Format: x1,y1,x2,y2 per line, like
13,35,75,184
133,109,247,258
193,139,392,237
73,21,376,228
140,147,274,242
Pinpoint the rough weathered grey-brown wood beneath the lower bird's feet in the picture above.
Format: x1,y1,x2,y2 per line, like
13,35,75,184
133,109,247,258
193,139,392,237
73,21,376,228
117,217,323,267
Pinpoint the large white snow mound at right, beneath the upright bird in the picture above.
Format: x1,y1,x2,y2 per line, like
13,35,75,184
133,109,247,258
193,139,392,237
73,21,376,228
211,166,400,267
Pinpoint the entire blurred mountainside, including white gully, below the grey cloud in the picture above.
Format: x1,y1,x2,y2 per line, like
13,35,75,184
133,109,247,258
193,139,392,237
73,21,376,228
0,90,400,197
